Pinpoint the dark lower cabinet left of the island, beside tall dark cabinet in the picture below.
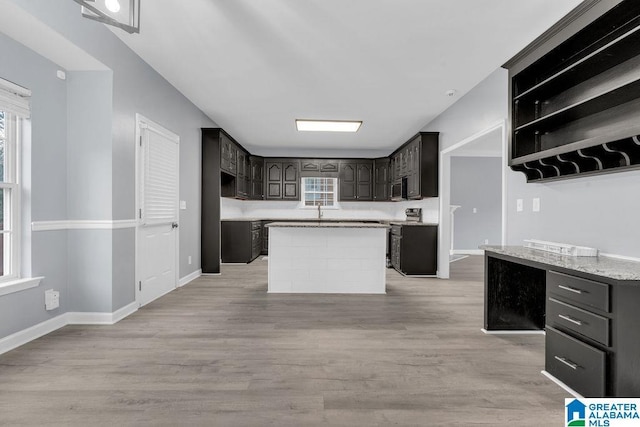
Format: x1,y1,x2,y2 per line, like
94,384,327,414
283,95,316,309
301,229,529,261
220,221,262,263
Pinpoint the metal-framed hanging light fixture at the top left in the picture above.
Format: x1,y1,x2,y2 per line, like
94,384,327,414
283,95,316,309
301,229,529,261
73,0,140,34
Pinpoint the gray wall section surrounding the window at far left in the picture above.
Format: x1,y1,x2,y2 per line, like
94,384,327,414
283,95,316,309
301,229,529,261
0,33,69,337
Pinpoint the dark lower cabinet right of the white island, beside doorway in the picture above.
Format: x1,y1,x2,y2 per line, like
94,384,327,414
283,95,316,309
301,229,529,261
389,224,438,276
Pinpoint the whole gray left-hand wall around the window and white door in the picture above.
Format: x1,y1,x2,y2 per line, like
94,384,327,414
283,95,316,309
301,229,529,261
0,0,216,338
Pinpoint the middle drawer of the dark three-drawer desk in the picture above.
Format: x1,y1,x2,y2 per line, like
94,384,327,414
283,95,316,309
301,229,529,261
546,297,609,346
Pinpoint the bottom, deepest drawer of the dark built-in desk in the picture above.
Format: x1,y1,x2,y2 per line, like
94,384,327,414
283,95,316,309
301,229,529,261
545,326,607,397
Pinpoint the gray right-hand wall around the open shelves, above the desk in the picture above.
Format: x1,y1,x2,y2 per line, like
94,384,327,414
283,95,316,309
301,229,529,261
423,69,640,258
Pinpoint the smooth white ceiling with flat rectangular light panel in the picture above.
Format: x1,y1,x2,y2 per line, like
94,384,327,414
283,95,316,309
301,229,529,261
114,0,580,155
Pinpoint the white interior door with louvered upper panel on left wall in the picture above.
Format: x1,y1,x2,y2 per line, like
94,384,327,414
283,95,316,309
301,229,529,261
136,118,180,306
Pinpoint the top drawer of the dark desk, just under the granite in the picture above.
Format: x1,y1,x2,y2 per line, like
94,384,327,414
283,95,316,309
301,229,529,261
547,271,609,313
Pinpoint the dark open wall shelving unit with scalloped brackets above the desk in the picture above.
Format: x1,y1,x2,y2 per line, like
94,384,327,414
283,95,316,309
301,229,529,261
509,0,640,182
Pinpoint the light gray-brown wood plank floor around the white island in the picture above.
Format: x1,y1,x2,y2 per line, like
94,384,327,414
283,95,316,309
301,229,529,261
0,257,569,427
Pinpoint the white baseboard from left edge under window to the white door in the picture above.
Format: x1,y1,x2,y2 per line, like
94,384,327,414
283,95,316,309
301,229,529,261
0,302,138,354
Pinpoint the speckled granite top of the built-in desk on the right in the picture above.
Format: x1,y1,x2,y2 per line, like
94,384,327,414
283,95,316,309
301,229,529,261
480,246,640,281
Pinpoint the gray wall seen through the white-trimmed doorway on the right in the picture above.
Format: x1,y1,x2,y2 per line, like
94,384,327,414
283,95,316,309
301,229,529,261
451,157,502,250
